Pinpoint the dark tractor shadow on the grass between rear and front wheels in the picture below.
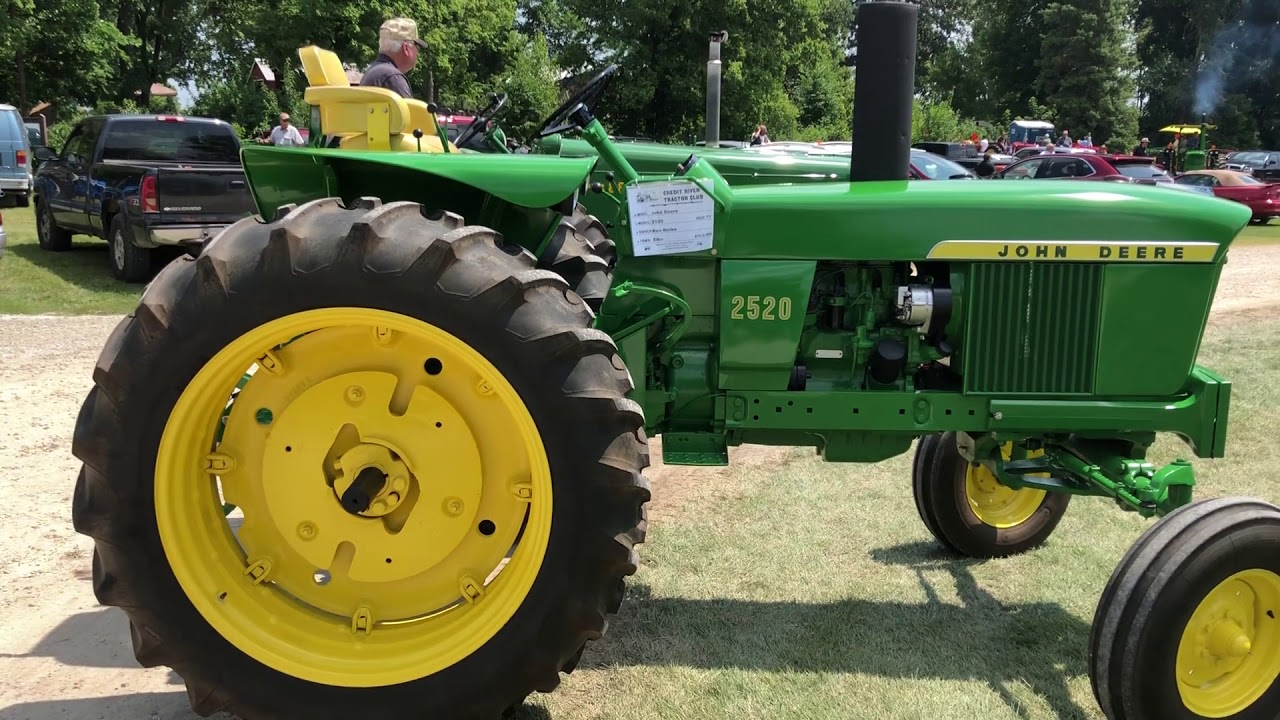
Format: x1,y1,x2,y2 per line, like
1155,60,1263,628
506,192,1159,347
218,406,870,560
580,542,1089,719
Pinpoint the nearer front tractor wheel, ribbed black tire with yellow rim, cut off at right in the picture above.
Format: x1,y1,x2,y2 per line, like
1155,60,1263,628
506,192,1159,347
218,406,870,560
1089,497,1280,720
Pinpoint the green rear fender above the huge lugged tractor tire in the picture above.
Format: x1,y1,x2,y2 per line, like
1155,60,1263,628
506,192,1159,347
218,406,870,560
241,146,598,251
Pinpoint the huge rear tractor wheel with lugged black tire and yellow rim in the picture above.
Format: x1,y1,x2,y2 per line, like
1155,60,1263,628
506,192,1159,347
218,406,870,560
73,199,649,720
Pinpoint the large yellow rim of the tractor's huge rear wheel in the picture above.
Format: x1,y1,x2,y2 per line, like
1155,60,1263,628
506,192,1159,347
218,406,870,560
155,307,552,687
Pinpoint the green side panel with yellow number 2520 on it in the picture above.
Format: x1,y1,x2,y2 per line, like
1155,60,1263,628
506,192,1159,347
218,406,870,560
719,260,817,389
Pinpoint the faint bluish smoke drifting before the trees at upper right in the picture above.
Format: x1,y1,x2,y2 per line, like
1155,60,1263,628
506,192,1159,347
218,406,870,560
1196,9,1280,115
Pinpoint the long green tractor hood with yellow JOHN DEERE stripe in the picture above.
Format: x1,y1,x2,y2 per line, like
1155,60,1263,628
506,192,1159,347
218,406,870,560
717,181,1251,261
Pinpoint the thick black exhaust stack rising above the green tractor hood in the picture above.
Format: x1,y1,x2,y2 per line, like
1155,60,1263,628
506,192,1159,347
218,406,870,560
849,0,920,182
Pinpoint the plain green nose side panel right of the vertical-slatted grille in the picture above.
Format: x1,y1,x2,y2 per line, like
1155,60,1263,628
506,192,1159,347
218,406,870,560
1096,264,1222,397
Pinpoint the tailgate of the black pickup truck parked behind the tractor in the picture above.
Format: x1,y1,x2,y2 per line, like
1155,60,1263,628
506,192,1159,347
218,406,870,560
156,164,256,224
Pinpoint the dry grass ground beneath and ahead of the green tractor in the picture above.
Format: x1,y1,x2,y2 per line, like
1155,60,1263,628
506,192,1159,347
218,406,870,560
526,310,1280,720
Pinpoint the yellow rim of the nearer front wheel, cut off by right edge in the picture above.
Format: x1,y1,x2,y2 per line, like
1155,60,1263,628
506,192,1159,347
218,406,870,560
1178,570,1280,717
